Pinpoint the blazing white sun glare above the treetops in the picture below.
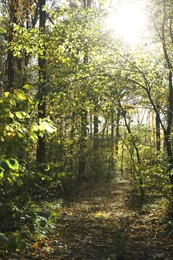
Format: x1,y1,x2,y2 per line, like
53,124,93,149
107,3,146,44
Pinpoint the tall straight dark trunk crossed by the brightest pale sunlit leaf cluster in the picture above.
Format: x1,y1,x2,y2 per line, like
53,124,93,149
37,0,46,163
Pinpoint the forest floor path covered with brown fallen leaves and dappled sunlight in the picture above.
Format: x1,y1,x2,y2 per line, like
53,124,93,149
13,180,173,260
